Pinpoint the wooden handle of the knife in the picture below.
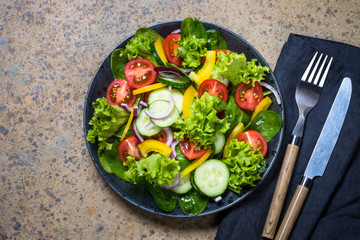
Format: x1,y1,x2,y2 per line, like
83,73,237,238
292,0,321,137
275,177,311,240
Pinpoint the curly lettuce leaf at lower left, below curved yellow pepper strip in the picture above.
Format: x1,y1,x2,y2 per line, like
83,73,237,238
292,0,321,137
122,153,180,186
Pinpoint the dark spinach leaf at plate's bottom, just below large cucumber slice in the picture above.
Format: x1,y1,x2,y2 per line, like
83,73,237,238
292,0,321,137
179,188,209,216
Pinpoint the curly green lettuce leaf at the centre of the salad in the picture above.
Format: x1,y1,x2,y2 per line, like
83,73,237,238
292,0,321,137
174,92,230,148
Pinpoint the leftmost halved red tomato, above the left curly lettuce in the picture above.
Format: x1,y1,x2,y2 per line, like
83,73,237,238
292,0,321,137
106,79,136,107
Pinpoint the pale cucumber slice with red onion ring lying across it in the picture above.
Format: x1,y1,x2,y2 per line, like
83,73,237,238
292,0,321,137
148,100,180,128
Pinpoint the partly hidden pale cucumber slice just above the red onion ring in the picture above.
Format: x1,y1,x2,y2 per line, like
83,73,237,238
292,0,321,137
148,87,184,113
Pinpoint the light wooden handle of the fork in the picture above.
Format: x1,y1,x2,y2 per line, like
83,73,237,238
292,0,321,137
262,144,299,239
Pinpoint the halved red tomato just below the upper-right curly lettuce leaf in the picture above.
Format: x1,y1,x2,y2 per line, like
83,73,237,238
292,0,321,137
235,81,263,111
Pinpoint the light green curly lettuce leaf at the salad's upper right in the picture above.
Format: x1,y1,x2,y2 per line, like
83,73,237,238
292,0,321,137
211,51,269,85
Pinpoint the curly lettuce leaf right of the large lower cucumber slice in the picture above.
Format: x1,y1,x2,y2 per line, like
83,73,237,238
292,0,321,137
223,139,266,194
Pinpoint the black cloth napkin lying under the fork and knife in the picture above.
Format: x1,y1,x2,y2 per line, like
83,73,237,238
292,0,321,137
215,34,360,240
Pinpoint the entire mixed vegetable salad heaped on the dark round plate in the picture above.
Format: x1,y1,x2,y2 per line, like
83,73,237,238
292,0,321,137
87,18,282,215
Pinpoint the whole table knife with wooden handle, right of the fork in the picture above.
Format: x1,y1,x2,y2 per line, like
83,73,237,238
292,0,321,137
275,77,352,240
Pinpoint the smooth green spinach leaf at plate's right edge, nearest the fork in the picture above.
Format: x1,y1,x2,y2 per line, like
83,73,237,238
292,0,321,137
246,110,282,142
